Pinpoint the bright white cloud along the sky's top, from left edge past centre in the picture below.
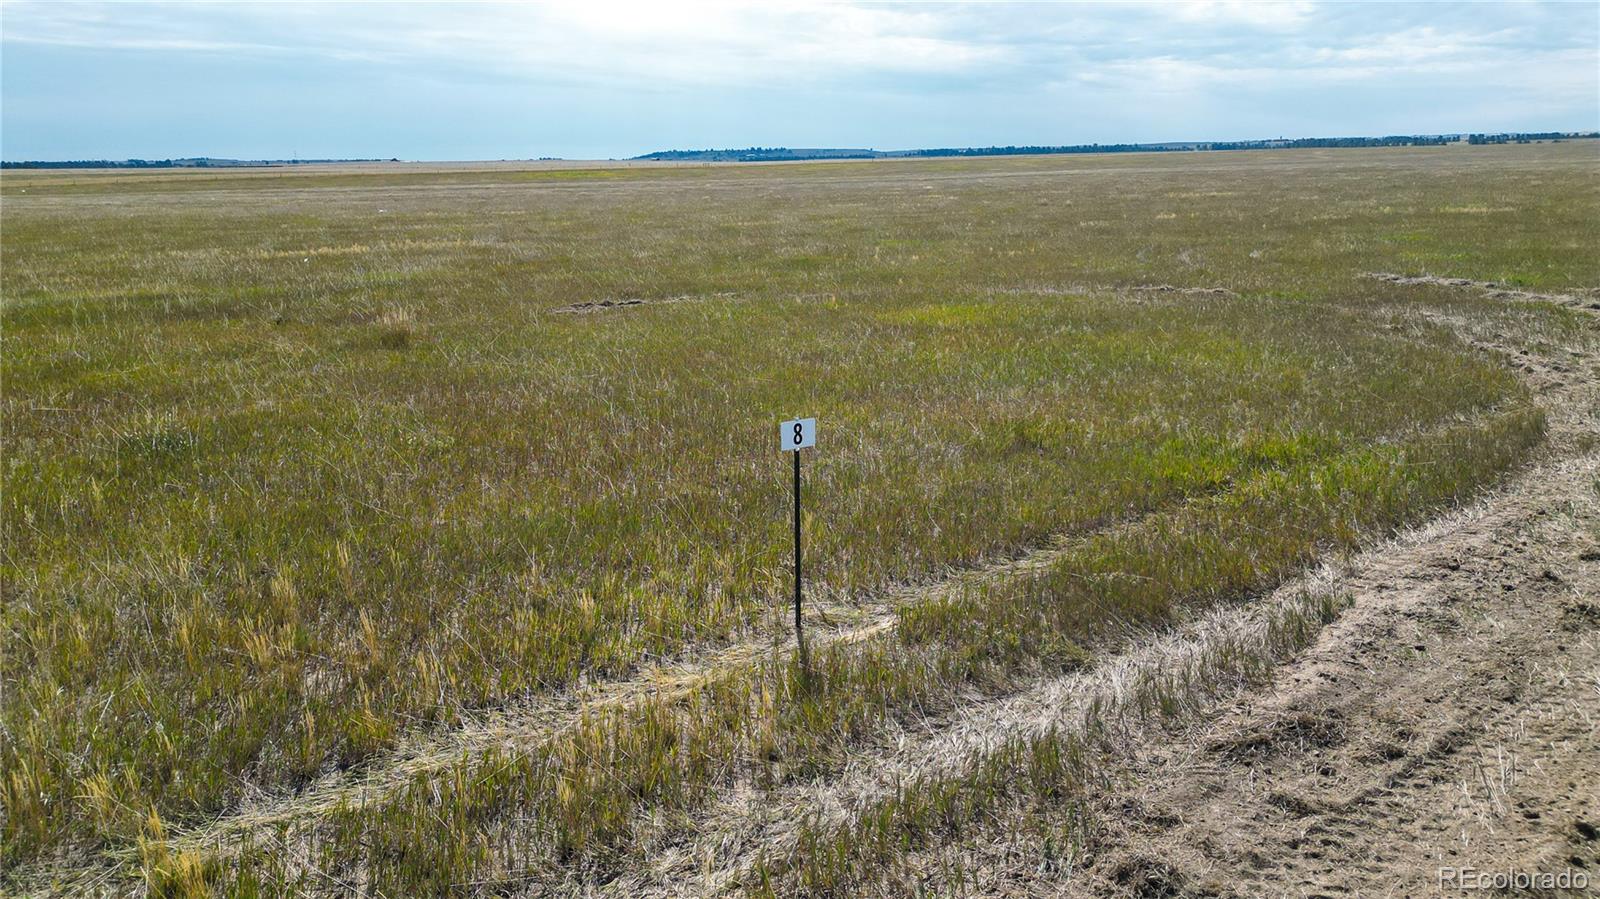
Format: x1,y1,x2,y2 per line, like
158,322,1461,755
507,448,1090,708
5,0,1010,83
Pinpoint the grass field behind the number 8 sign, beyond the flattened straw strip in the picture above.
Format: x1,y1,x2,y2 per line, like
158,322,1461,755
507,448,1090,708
0,144,1600,867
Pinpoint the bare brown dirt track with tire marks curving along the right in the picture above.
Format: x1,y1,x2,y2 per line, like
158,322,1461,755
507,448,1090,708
947,280,1600,897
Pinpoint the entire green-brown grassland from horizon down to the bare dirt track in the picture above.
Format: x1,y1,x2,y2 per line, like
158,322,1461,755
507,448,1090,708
0,144,1600,896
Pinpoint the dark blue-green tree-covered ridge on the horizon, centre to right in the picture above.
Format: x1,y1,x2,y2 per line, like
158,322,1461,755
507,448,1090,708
634,131,1600,162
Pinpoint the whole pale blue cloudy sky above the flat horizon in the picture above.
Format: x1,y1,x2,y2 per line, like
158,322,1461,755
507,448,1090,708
0,0,1600,160
